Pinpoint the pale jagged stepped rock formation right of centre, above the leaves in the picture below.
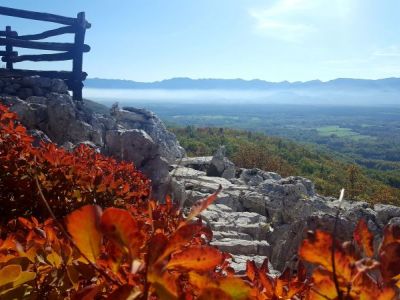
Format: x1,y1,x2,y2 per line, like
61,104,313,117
171,151,400,271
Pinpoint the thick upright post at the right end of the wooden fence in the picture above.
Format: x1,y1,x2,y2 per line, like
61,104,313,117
72,12,86,101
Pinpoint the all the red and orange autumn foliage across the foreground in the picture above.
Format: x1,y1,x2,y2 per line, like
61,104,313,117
0,102,400,300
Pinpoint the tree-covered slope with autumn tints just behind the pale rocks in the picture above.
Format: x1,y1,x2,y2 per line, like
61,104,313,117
172,126,400,204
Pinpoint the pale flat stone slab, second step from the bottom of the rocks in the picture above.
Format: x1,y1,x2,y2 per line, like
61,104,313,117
211,238,271,256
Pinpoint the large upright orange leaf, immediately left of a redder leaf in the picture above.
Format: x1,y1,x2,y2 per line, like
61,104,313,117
66,205,102,263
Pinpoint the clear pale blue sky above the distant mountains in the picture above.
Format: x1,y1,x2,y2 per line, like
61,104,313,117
0,0,400,81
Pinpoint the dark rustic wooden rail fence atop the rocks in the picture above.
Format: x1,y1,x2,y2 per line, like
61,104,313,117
0,6,91,101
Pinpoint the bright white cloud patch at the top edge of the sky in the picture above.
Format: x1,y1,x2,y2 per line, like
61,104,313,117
249,0,356,42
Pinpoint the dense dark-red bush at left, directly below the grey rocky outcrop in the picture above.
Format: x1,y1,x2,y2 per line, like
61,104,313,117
0,104,150,220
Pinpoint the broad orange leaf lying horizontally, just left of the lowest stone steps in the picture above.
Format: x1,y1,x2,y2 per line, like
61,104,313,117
166,246,224,271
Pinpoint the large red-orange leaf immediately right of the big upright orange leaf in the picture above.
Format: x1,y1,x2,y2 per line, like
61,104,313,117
100,207,145,257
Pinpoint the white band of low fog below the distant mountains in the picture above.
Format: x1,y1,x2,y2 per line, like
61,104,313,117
84,88,400,106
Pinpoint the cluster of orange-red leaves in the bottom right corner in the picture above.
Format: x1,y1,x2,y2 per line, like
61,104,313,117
299,220,400,300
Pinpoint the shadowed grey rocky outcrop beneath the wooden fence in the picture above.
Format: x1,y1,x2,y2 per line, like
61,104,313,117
0,76,184,200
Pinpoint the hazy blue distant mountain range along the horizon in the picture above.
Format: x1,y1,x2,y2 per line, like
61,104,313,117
85,78,400,92
